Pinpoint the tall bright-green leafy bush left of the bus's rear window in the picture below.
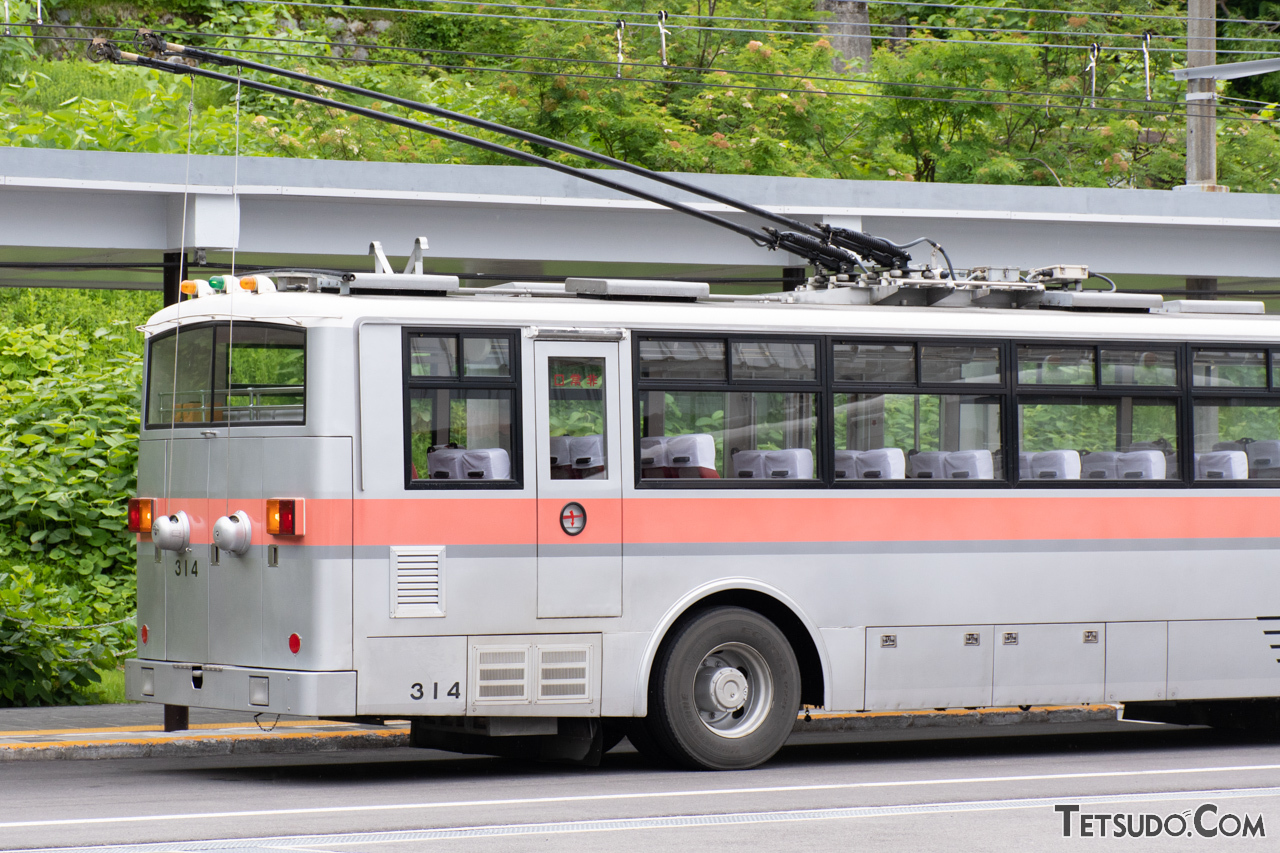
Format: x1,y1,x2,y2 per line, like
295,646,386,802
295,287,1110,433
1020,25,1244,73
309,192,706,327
0,325,142,578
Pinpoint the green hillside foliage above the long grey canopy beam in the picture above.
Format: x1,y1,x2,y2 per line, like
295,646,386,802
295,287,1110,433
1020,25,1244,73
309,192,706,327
0,0,1280,192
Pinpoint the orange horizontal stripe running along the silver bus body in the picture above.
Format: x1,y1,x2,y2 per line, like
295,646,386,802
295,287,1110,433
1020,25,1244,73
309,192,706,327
140,493,1280,546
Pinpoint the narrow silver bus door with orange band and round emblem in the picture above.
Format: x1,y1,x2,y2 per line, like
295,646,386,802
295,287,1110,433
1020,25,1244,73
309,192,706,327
534,341,622,619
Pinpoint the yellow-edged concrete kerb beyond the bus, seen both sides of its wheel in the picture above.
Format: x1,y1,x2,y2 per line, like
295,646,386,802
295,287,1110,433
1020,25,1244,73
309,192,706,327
0,704,1119,761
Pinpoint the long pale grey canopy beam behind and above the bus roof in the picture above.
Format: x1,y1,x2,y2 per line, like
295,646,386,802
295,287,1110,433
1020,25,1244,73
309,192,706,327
0,149,1280,288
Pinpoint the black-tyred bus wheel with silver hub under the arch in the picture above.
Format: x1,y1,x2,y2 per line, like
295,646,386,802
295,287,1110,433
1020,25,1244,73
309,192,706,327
645,607,800,770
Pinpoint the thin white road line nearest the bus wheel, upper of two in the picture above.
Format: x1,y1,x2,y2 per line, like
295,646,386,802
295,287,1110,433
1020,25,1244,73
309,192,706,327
0,765,1280,824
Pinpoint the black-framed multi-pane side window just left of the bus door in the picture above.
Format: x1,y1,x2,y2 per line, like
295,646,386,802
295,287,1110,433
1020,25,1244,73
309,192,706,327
406,332,520,488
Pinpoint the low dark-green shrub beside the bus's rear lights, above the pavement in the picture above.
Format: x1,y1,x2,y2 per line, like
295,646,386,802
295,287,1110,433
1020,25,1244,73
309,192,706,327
0,565,133,706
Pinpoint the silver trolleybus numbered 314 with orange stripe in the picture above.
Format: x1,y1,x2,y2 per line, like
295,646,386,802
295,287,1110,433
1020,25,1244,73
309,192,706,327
127,256,1280,768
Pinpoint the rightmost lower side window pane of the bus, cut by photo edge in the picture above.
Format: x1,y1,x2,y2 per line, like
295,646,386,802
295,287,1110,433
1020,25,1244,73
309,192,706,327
1193,397,1280,480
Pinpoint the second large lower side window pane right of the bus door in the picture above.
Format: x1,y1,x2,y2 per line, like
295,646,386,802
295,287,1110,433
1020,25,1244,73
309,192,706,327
835,393,1004,480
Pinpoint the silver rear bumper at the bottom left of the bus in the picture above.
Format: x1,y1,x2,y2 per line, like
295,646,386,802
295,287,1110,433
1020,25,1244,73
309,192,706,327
124,658,356,717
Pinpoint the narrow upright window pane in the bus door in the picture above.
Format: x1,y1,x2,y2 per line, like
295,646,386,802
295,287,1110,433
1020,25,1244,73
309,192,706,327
547,359,609,480
